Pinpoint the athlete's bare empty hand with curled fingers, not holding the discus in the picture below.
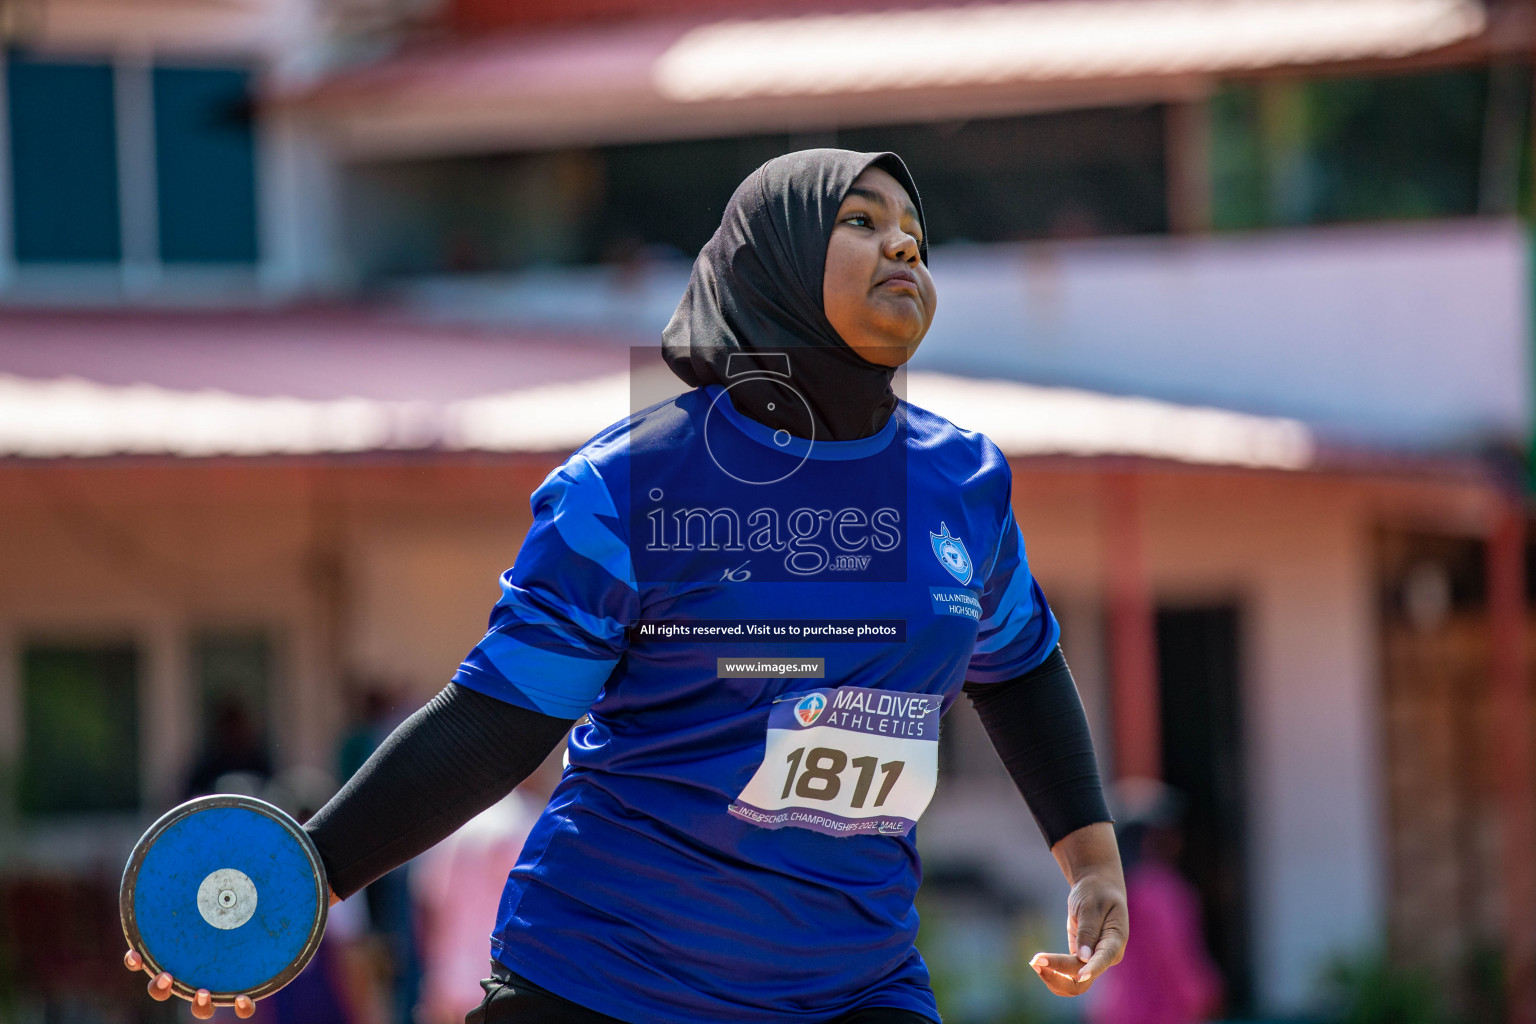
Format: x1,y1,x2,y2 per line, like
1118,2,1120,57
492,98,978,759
1029,821,1130,996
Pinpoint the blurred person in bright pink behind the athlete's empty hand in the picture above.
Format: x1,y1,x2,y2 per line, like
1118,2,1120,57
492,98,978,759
1087,780,1223,1024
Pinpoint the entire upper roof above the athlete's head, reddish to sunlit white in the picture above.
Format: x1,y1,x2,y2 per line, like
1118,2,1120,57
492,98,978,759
293,0,1488,157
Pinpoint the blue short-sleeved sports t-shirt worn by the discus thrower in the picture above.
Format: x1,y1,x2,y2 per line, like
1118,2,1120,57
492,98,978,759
453,387,1060,1024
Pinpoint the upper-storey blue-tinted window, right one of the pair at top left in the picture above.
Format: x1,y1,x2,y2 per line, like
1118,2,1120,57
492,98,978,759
154,68,257,263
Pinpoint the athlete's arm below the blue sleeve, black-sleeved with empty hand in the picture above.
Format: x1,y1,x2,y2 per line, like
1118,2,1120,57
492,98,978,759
965,648,1129,995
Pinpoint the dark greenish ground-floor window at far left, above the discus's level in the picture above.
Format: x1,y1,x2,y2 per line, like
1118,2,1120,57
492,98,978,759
17,645,138,815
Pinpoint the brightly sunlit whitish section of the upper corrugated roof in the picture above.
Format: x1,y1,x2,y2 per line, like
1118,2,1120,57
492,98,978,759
653,0,1487,101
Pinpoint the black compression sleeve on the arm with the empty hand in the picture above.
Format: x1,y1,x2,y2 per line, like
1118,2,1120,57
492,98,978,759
965,646,1111,846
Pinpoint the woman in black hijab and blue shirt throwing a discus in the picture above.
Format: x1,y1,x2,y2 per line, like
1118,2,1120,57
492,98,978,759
127,149,1127,1024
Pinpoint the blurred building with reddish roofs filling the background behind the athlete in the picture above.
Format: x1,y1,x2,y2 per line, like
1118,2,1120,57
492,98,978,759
0,0,1536,1019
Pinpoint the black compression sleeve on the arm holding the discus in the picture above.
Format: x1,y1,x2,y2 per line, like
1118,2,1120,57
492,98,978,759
304,683,573,900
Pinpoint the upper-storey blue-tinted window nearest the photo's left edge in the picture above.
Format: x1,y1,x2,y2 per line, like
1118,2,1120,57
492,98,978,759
6,55,121,263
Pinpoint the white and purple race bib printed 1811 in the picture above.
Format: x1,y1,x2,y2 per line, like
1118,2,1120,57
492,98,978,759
730,686,943,835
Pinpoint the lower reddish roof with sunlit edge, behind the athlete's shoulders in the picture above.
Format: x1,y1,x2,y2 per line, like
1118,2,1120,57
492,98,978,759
0,303,1316,470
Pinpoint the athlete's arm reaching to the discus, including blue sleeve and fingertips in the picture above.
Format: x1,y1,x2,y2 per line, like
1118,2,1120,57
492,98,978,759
127,454,641,1018
